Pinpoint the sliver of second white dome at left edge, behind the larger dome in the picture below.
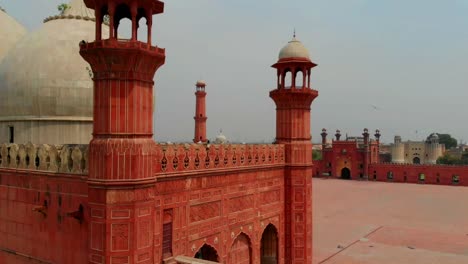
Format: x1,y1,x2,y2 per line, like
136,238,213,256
0,7,27,61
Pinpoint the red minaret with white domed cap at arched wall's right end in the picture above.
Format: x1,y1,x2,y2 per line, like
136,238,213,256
270,34,318,263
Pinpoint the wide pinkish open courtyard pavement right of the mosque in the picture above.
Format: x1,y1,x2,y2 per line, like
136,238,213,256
313,179,468,264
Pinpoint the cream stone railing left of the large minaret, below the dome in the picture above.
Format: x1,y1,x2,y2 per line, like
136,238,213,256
0,143,88,174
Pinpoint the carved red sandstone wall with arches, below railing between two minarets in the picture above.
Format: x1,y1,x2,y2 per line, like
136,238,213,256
155,167,284,263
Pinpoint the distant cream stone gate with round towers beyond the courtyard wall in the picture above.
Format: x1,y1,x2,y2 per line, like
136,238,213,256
390,133,445,164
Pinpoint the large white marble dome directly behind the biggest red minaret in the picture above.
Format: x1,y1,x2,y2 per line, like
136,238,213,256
0,0,108,144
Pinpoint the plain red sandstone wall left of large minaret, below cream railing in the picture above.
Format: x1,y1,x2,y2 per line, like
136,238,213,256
0,168,88,264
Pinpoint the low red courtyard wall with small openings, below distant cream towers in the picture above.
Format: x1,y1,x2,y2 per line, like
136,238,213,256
369,163,468,186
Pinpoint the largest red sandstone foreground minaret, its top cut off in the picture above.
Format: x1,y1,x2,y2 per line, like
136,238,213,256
77,0,165,263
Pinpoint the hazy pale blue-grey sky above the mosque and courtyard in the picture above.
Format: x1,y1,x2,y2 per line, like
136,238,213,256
0,0,468,142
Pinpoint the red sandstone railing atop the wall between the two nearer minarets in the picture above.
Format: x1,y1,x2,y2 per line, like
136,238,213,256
153,144,284,173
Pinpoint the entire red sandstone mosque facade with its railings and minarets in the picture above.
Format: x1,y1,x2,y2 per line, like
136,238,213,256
0,0,318,264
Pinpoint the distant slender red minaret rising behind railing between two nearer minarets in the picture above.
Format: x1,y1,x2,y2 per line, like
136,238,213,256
193,81,208,143
